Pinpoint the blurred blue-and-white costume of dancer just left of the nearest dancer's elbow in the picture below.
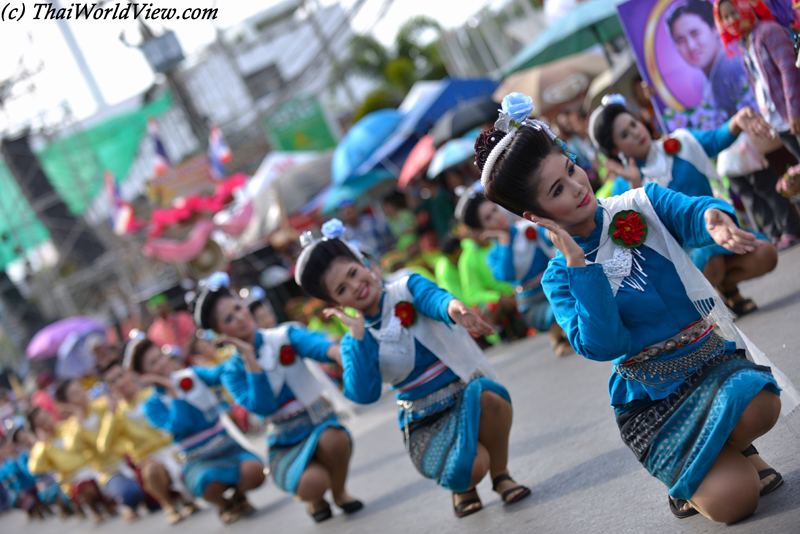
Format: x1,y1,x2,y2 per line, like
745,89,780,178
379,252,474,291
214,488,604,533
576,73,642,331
486,220,555,332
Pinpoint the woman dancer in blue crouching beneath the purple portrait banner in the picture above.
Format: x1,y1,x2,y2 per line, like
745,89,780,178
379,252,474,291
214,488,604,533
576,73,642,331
589,95,778,315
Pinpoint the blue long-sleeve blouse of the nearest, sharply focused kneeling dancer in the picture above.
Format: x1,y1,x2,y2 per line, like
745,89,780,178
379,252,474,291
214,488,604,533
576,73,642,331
542,184,736,405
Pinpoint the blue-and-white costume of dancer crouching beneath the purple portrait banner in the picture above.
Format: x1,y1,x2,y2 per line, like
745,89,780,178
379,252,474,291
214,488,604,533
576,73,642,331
614,121,769,271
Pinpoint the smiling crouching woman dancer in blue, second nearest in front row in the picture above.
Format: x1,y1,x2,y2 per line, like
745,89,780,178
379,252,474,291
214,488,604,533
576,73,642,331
295,219,530,517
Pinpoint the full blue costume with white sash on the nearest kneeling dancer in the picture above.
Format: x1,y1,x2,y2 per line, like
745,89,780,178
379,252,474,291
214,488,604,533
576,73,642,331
542,184,800,499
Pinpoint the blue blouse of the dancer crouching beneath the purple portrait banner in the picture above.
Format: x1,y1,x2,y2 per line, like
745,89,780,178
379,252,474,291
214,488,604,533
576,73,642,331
613,121,736,197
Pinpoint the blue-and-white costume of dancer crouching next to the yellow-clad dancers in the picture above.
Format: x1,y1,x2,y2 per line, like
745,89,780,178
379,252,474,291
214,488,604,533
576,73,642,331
142,364,260,497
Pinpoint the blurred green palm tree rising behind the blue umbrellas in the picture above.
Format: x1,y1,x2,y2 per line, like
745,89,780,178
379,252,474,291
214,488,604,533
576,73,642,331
332,16,447,122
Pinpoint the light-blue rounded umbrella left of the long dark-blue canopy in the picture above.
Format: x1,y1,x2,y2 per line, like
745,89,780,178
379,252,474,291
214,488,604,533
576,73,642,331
331,109,403,185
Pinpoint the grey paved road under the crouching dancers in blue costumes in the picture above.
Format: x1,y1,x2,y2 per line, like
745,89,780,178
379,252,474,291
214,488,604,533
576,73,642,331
7,247,800,534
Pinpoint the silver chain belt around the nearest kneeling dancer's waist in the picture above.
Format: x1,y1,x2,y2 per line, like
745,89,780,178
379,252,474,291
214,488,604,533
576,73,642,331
614,332,725,389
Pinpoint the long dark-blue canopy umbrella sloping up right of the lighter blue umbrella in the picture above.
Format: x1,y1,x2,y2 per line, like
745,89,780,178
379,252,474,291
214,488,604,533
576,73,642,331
356,78,498,175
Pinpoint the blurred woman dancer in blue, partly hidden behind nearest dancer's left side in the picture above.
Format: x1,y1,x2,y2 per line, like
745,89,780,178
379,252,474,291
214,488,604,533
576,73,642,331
456,182,573,356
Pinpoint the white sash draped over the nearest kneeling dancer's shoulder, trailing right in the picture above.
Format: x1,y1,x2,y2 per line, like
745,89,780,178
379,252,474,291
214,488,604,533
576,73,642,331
596,188,800,420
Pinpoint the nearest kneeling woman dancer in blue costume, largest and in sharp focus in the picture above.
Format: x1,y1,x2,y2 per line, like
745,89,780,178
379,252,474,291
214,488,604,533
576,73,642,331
475,93,800,523
